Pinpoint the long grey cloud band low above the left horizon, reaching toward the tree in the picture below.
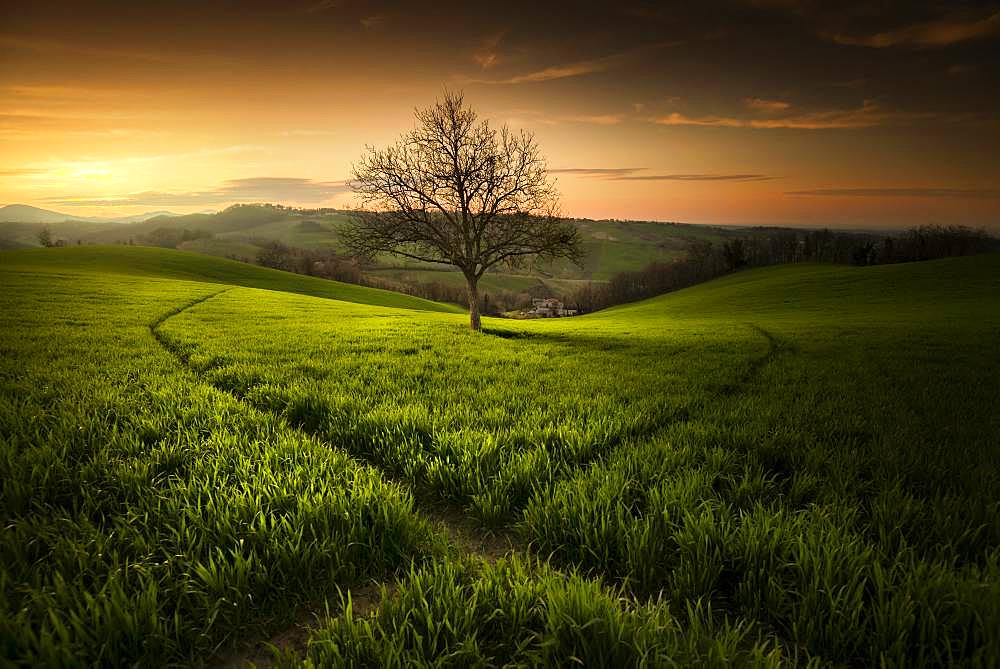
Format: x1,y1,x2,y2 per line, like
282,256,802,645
46,177,349,207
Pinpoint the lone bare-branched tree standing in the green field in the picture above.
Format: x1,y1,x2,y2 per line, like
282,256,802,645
343,92,580,330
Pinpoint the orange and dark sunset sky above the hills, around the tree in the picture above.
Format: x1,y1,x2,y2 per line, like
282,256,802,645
0,0,1000,230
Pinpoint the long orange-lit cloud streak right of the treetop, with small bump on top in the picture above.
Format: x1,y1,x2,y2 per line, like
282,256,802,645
654,100,936,130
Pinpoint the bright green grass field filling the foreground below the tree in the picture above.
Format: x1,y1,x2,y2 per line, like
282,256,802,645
0,247,1000,667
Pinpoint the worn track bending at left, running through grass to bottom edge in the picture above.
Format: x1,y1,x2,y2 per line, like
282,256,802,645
148,287,528,667
